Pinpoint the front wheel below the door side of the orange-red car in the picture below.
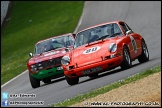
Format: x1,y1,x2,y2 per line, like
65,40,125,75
121,46,132,70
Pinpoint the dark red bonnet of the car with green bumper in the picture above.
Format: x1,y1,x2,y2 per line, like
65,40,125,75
28,48,72,64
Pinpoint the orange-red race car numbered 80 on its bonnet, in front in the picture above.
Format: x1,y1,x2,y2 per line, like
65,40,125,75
61,21,149,85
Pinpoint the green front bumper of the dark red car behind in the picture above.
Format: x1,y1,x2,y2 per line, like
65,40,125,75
31,67,64,79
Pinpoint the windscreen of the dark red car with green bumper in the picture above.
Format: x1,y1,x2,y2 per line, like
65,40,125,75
34,35,74,55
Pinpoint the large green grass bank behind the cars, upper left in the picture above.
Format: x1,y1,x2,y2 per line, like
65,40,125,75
1,1,84,85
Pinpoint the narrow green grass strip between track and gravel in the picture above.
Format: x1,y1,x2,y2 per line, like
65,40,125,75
50,66,161,107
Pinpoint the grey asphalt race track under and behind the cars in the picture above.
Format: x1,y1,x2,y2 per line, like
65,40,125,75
1,1,161,107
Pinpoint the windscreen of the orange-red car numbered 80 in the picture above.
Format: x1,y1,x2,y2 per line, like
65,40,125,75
74,23,122,48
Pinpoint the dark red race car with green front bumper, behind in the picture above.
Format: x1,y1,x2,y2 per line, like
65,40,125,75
27,33,75,88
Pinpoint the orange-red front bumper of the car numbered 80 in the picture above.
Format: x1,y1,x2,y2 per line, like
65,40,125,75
64,56,123,78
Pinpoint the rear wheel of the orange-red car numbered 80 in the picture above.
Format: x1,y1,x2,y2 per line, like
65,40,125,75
138,40,149,63
